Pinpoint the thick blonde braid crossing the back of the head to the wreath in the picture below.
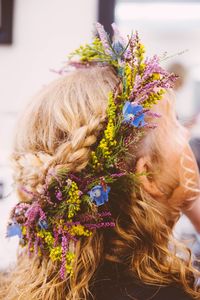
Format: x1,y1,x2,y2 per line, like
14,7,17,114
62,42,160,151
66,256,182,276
13,116,105,193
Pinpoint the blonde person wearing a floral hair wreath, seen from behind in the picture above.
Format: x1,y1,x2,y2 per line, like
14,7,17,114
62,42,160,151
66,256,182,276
0,25,200,300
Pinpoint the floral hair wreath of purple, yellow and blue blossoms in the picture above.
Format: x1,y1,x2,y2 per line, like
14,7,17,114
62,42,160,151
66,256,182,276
7,23,176,279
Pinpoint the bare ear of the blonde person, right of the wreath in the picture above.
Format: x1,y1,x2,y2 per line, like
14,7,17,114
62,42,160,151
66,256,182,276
136,156,165,200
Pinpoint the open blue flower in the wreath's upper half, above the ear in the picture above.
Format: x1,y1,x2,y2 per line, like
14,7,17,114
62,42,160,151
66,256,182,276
123,101,146,127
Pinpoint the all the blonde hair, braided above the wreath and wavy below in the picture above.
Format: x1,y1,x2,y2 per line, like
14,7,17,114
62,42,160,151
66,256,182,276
0,67,200,300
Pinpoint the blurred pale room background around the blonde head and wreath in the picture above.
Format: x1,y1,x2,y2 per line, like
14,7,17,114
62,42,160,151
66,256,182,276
0,0,200,269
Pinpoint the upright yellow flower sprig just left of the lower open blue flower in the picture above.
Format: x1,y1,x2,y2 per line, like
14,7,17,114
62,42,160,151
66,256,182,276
67,181,81,219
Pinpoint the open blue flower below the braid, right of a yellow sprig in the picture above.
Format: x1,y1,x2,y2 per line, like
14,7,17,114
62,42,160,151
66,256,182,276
88,185,110,206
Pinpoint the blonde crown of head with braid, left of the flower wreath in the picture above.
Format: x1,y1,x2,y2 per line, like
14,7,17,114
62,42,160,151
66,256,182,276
13,67,119,191
